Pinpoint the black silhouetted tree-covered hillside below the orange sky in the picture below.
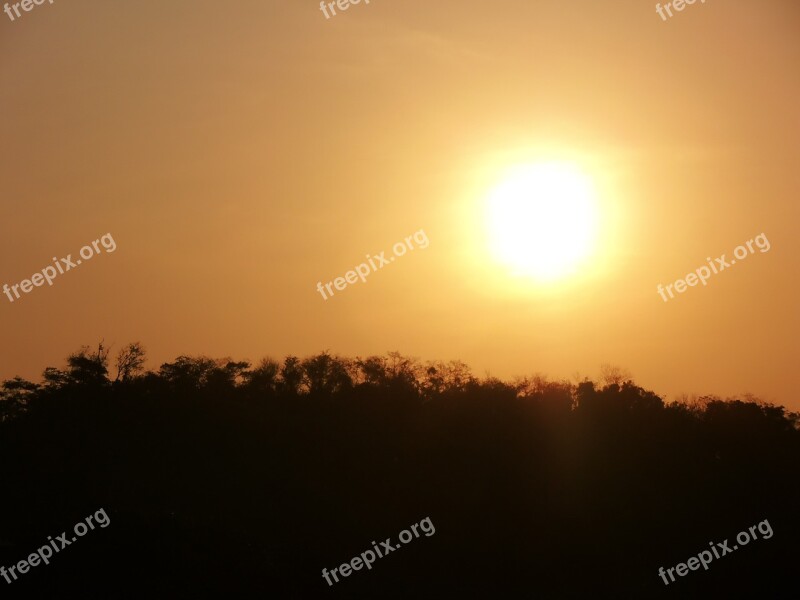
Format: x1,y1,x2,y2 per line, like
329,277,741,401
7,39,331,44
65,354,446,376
0,344,800,599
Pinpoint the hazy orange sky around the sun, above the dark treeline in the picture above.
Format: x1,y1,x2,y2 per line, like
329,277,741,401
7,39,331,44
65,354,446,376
0,0,800,410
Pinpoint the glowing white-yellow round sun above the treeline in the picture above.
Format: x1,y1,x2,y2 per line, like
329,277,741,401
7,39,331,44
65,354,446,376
486,162,597,281
